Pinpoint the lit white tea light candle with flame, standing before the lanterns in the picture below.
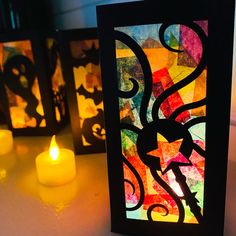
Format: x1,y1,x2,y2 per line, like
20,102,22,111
35,135,76,186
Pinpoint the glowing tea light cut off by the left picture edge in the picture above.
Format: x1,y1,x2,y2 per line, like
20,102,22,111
0,129,13,155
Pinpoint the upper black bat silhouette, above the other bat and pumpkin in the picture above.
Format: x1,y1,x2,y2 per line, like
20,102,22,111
72,43,99,67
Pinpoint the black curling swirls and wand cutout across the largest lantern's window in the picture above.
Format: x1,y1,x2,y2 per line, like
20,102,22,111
115,22,207,223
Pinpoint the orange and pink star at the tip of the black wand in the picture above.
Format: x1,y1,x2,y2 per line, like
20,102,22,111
147,133,190,174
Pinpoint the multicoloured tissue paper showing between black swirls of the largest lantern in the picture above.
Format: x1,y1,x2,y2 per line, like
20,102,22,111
115,21,207,224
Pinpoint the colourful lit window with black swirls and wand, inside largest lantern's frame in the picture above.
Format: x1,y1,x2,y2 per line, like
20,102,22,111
115,21,207,224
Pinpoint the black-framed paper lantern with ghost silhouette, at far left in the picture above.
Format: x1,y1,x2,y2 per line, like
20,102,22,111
0,32,67,135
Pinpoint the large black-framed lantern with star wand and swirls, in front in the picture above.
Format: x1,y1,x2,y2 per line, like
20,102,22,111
97,0,234,236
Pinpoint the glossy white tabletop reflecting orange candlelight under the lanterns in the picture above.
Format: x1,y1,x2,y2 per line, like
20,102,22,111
0,127,236,236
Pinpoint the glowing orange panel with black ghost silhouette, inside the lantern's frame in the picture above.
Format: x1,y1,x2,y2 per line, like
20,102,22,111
0,40,46,128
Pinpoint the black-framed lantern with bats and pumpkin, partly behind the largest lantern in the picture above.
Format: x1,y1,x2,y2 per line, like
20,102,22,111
60,28,105,154
